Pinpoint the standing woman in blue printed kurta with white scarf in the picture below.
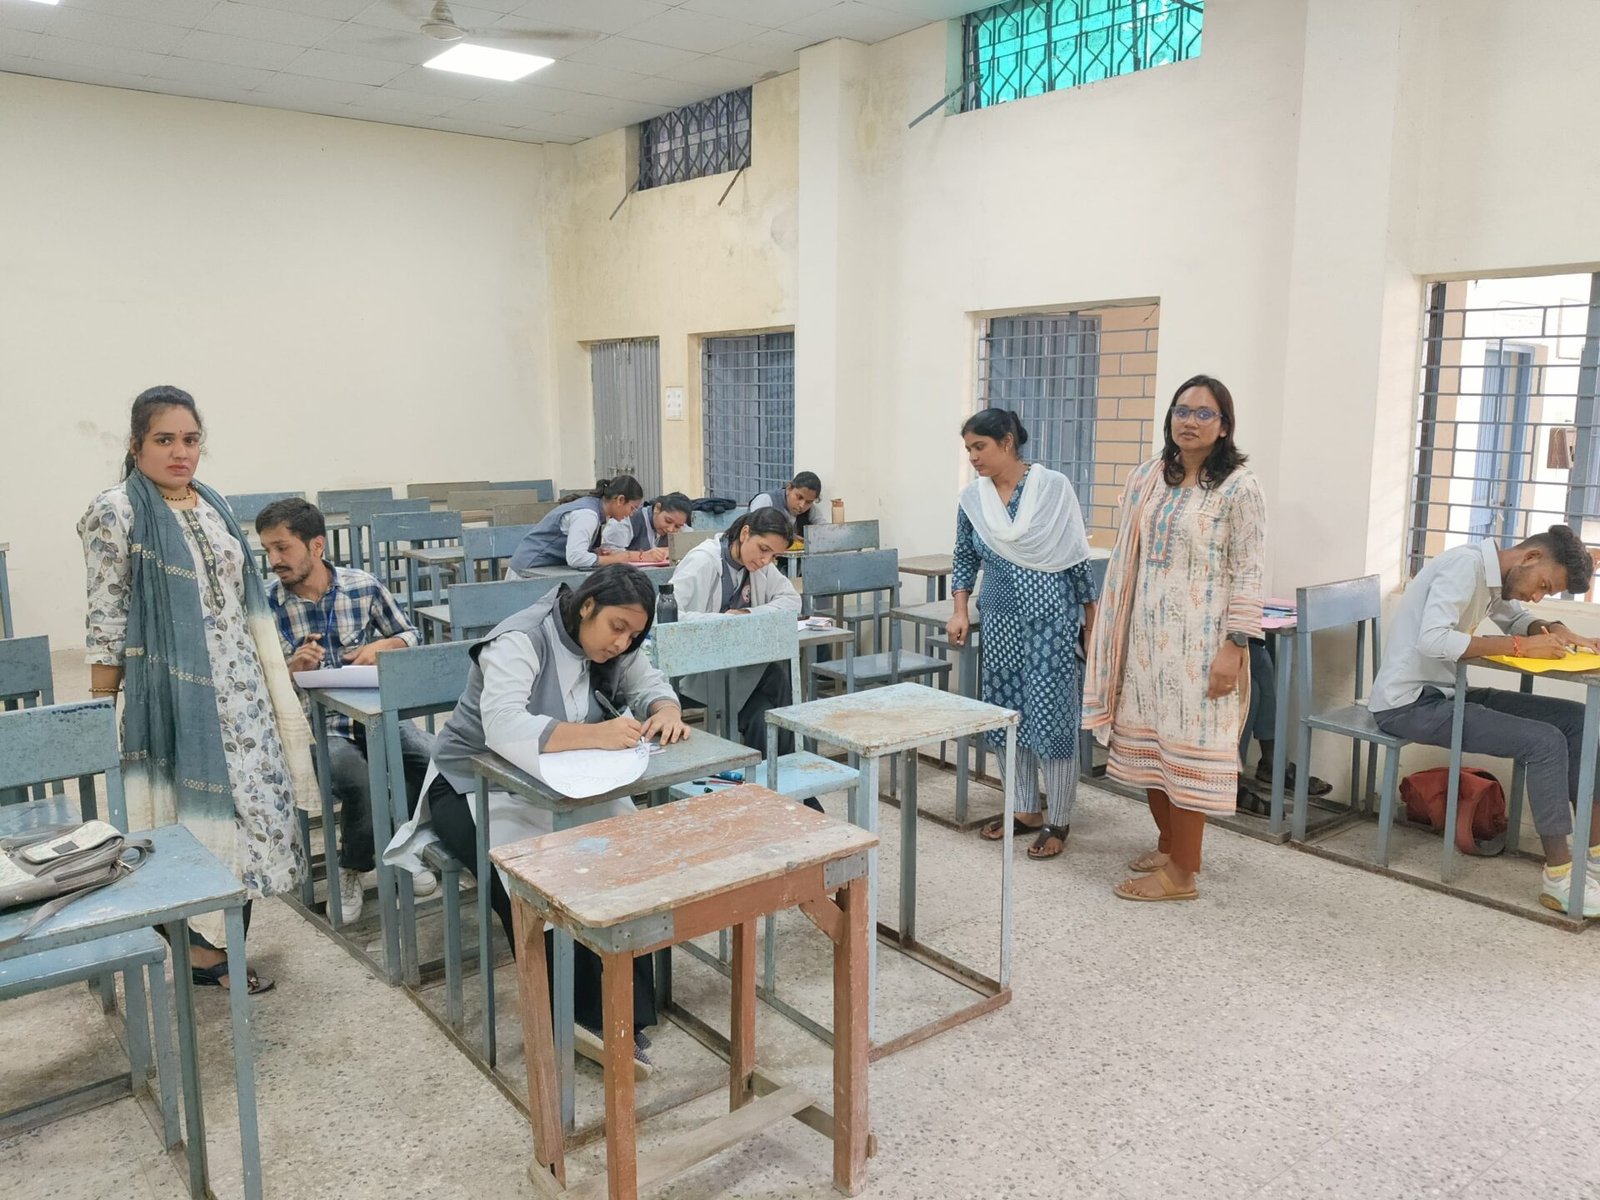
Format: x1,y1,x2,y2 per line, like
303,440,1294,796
949,408,1096,858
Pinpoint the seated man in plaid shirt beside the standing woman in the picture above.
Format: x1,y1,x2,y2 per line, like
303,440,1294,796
256,498,438,922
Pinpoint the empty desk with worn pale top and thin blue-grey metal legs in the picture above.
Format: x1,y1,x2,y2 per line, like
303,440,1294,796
766,683,1018,1058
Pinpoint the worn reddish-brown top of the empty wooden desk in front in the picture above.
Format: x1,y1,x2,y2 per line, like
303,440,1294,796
490,784,878,930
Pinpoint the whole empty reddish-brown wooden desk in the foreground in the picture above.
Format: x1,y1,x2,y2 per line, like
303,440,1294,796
491,786,878,1200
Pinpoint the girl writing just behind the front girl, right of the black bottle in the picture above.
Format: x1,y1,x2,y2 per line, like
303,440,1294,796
672,507,806,808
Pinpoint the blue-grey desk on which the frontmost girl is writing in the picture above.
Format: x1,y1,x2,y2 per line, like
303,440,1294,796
472,730,762,1131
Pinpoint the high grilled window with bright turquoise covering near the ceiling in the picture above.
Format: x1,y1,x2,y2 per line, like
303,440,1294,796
962,0,1205,110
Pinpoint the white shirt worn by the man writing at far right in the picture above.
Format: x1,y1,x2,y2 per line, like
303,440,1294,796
1368,542,1534,712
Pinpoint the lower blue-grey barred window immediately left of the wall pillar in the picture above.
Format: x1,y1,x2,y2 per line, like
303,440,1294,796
701,333,795,504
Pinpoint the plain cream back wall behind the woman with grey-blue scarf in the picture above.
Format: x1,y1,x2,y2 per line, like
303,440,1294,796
0,74,560,646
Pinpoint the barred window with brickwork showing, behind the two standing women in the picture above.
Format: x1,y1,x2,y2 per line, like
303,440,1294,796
978,302,1160,546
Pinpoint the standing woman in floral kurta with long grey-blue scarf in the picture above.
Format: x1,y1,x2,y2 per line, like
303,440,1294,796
78,387,314,992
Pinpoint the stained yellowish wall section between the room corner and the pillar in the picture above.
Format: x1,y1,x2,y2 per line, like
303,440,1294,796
546,72,798,496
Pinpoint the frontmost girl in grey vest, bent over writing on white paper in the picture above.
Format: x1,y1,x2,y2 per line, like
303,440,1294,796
384,565,688,1066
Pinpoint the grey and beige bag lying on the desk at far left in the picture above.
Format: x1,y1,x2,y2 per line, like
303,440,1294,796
0,821,150,949
